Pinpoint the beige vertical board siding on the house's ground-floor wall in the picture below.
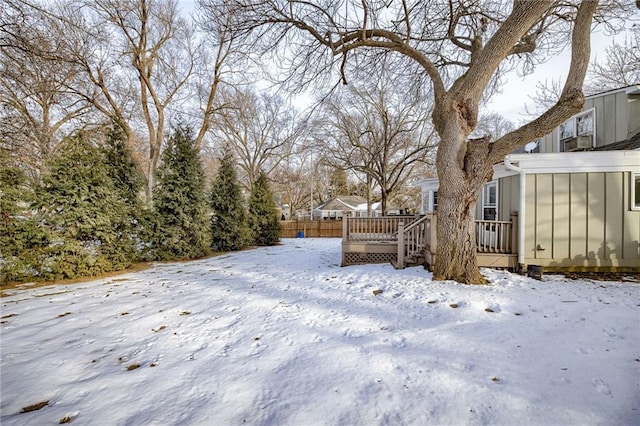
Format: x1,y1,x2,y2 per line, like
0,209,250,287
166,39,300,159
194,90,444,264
524,172,640,270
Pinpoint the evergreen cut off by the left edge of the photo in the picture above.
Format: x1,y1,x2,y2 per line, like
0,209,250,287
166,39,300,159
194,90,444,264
0,151,49,284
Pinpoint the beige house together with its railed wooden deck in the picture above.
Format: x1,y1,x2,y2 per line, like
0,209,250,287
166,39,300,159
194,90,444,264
342,85,640,272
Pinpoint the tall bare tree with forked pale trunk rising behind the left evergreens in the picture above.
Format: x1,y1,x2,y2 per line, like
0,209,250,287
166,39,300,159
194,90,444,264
78,0,196,200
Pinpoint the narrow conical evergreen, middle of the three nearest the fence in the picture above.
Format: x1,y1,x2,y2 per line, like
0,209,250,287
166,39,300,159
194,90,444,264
210,147,250,251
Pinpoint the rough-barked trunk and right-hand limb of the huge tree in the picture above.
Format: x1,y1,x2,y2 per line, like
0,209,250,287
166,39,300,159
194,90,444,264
433,1,598,284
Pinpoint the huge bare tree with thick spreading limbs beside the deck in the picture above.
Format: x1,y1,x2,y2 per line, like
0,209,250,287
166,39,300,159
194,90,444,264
211,0,635,283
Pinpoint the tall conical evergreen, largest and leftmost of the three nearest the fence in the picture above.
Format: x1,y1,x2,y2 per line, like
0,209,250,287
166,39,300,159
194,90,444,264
151,124,211,260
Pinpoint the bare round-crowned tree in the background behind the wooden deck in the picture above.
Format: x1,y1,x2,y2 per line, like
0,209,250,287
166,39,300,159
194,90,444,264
316,72,436,214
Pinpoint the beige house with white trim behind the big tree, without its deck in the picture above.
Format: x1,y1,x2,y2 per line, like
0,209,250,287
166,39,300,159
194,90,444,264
418,85,640,271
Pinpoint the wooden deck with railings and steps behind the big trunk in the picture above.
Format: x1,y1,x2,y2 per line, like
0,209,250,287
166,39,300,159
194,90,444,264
342,214,518,269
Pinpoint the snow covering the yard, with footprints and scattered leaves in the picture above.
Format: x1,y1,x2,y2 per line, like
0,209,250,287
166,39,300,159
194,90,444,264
0,239,640,426
